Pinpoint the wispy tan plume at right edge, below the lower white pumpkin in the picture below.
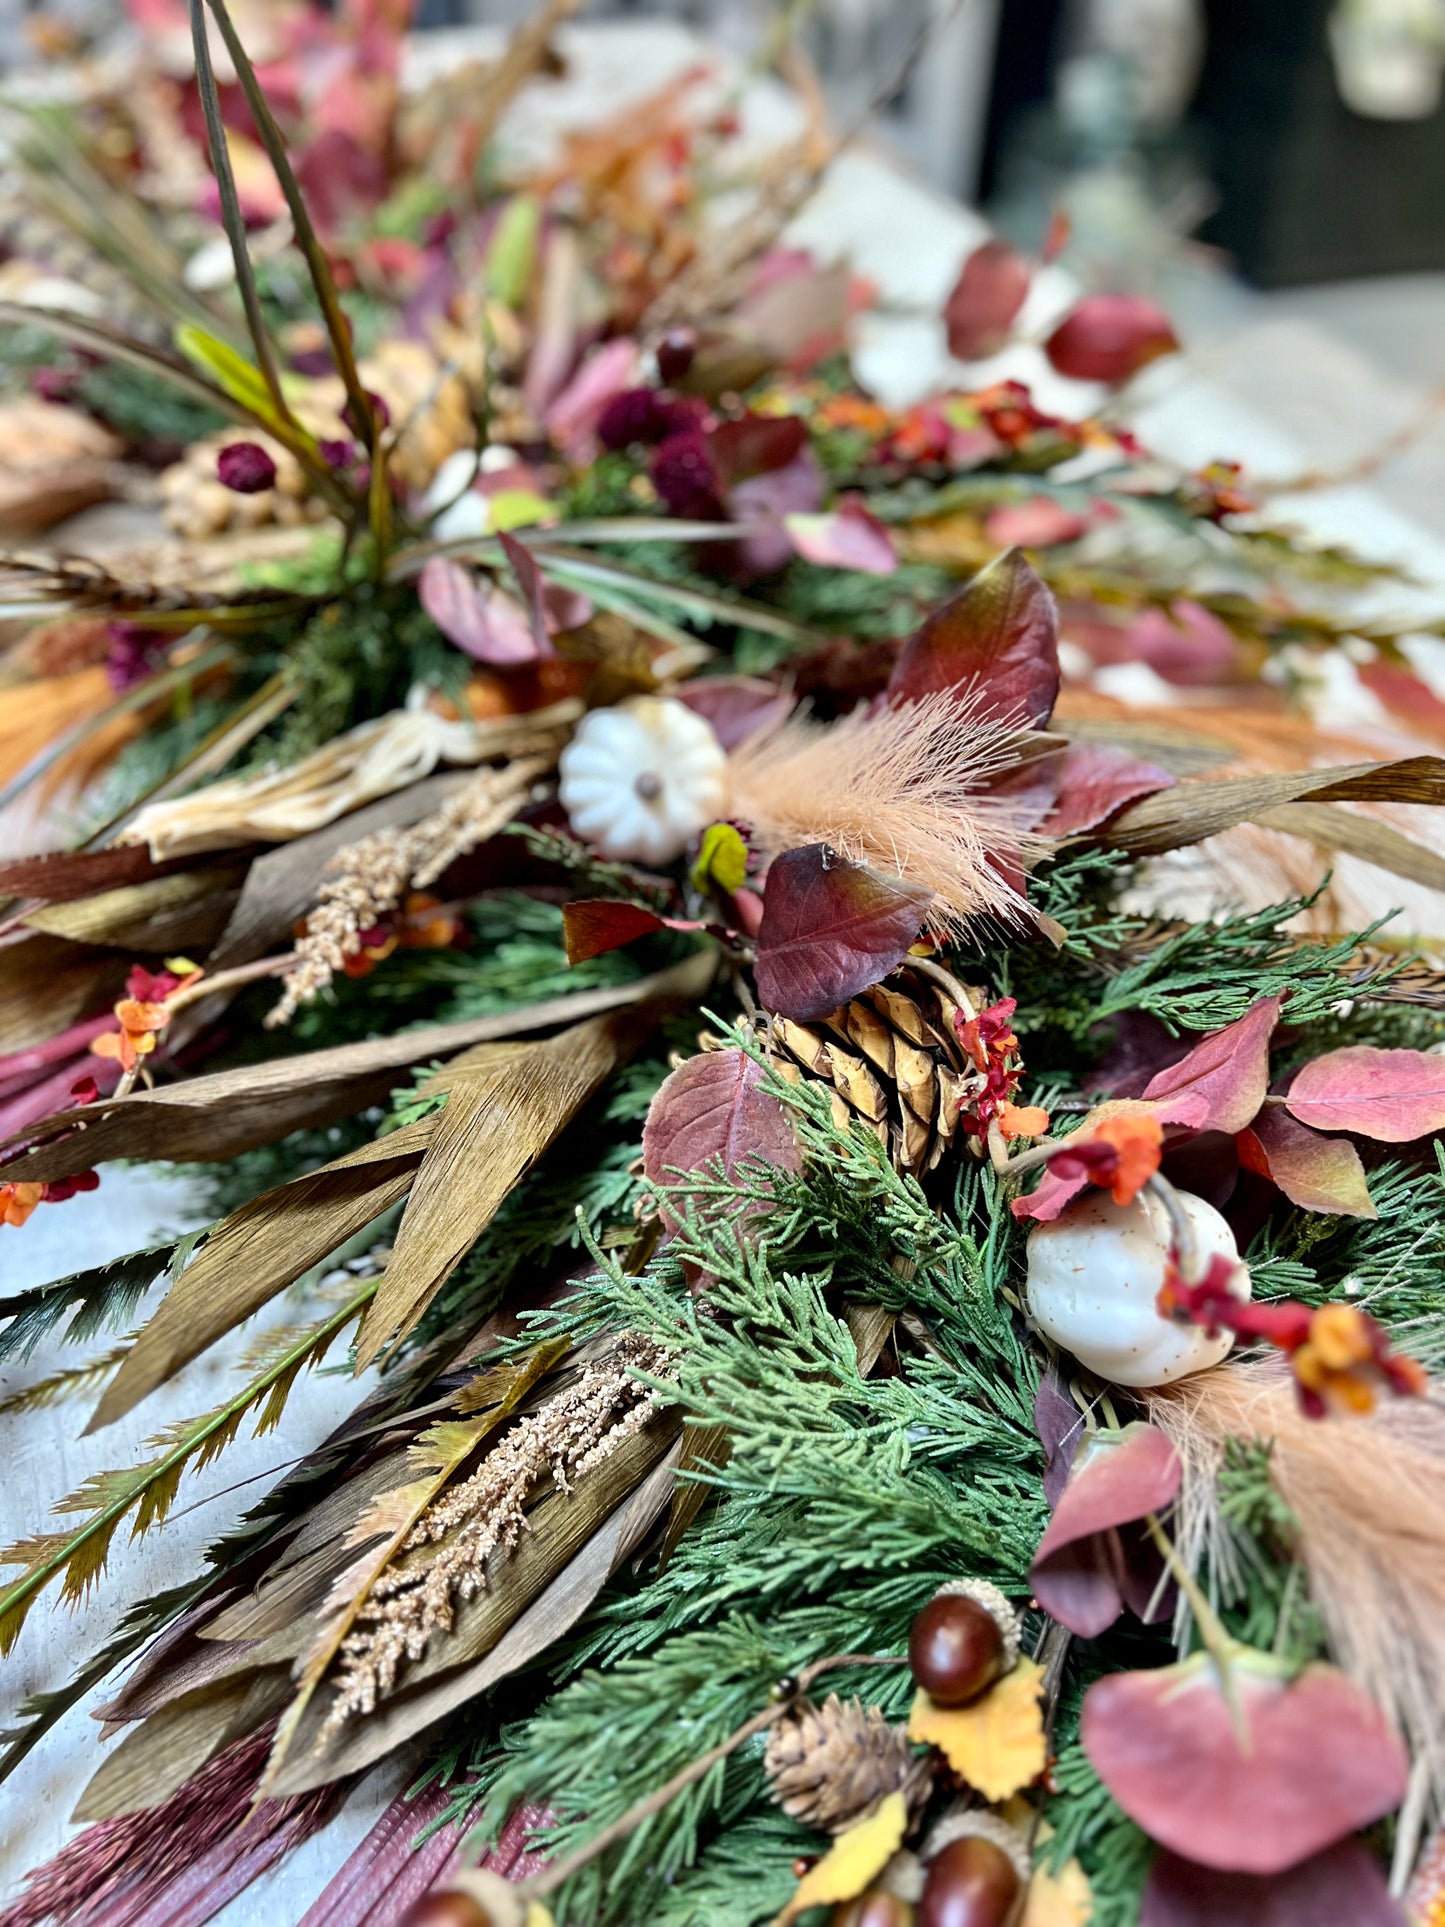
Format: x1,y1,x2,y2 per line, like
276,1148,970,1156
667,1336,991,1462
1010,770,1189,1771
1146,1359,1445,1782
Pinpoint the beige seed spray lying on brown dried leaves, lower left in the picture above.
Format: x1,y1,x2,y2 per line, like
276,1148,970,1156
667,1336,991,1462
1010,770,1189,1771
324,1332,667,1736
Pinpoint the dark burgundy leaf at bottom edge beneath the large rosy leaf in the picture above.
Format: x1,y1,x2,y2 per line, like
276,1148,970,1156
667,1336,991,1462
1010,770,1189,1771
1139,1840,1405,1927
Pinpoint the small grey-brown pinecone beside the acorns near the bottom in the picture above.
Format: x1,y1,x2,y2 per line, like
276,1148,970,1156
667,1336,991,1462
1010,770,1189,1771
763,1692,933,1833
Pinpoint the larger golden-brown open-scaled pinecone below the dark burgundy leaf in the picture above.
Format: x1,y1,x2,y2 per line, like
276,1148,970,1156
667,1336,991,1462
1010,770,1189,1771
771,964,977,1177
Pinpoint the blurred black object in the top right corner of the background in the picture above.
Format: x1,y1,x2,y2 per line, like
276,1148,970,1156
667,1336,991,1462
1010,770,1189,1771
1193,0,1445,287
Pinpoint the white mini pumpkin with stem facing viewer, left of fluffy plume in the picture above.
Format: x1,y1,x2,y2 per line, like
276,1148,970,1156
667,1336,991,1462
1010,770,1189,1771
559,696,728,863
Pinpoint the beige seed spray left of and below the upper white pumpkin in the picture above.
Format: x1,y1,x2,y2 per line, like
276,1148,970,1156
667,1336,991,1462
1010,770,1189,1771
266,755,553,1027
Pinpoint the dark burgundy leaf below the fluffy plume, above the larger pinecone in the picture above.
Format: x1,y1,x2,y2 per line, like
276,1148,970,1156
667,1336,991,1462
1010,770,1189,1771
755,844,933,1021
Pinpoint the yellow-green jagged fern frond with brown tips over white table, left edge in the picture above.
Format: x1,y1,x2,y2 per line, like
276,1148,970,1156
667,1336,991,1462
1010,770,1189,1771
0,1280,378,1655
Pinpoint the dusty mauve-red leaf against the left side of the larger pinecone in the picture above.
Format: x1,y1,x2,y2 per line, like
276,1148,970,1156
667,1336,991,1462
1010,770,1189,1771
642,1050,801,1225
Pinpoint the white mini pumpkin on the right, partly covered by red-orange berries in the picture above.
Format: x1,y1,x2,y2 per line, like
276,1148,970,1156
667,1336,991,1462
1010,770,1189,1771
1029,1191,1250,1386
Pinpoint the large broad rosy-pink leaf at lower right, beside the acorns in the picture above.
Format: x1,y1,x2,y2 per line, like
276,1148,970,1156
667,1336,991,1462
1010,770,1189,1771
1079,1648,1410,1873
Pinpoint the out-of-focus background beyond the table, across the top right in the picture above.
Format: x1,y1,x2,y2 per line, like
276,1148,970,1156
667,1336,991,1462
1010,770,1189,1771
0,0,1445,532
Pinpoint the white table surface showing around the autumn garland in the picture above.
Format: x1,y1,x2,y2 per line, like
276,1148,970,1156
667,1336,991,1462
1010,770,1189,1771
0,11,1445,1927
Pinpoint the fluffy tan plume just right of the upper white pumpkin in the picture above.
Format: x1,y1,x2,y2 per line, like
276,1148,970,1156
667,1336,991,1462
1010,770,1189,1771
730,692,1033,933
